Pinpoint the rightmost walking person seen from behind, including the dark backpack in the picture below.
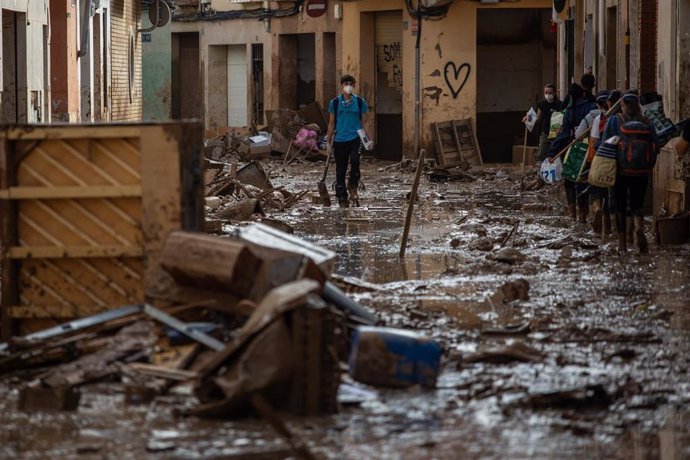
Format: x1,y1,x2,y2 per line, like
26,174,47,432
602,91,659,254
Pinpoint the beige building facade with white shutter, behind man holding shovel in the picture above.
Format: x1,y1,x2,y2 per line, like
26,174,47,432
170,0,342,135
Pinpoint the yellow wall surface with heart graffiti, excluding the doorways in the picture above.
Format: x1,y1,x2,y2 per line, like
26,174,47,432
342,0,551,157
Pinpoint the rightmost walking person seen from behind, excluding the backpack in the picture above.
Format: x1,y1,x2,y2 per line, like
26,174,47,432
602,91,659,254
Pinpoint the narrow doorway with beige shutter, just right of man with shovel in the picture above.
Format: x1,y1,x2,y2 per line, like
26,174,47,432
374,11,403,159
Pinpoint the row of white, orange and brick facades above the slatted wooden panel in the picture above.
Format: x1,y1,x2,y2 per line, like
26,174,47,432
0,0,142,123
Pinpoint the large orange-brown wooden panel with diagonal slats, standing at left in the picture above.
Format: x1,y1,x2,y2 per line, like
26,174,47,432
0,123,203,340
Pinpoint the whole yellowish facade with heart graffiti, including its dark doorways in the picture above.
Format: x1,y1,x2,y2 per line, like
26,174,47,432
342,0,556,161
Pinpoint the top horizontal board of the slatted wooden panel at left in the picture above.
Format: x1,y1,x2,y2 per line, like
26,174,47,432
0,125,142,141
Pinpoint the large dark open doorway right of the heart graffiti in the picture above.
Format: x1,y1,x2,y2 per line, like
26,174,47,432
476,8,556,163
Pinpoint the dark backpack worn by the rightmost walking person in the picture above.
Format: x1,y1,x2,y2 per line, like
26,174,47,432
617,114,657,176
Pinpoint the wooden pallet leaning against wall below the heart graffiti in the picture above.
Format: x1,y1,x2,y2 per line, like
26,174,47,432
431,118,484,167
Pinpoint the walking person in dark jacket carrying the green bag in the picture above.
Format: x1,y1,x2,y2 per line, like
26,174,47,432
549,83,596,224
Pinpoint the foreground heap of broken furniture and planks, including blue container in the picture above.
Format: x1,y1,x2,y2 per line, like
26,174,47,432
0,224,441,454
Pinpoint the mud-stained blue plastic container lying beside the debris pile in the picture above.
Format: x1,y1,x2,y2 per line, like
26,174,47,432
350,326,441,388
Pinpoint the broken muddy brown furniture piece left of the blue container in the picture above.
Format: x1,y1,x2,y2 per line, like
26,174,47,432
191,280,346,418
